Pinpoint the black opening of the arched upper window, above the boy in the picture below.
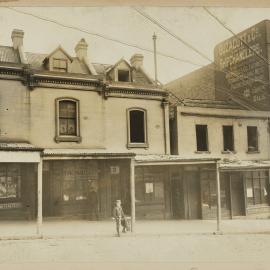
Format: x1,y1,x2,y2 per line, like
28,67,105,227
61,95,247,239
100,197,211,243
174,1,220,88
129,110,145,143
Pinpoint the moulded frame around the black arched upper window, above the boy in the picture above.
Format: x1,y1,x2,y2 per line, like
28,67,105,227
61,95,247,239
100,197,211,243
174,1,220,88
127,107,149,148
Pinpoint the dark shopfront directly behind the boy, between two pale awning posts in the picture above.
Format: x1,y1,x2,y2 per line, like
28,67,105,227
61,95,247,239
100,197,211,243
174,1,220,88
43,157,133,220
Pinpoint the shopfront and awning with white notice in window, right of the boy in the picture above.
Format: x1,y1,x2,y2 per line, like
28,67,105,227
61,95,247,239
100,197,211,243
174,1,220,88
135,156,220,219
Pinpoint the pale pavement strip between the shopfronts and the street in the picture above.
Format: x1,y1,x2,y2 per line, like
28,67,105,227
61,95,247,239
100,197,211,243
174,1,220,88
0,219,270,240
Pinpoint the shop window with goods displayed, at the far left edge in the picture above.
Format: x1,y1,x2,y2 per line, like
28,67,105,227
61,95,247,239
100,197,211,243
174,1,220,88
0,164,21,201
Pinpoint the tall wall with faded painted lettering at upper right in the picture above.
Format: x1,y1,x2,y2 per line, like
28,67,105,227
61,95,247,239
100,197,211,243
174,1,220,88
214,21,270,110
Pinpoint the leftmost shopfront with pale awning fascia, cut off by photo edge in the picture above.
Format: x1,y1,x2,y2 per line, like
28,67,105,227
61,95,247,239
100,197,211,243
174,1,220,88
0,144,40,220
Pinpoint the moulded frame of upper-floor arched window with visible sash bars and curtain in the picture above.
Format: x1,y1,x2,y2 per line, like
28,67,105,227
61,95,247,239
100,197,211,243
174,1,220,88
55,97,81,143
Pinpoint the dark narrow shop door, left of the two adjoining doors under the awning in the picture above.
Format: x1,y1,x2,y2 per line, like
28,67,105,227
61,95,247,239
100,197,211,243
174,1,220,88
171,174,185,219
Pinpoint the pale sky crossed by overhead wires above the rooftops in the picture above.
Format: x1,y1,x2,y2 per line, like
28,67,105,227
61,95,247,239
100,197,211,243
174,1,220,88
0,6,270,83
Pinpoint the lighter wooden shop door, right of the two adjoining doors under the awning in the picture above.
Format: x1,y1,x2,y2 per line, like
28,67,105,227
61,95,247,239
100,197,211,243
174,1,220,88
185,172,201,219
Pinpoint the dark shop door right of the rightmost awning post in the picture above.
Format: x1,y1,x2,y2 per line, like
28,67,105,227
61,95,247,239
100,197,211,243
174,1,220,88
230,173,245,216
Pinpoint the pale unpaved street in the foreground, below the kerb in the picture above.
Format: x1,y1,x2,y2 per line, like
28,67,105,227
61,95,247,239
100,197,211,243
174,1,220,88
0,233,270,270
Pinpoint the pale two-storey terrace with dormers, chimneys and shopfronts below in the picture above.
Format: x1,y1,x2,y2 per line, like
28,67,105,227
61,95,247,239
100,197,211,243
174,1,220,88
0,30,221,226
